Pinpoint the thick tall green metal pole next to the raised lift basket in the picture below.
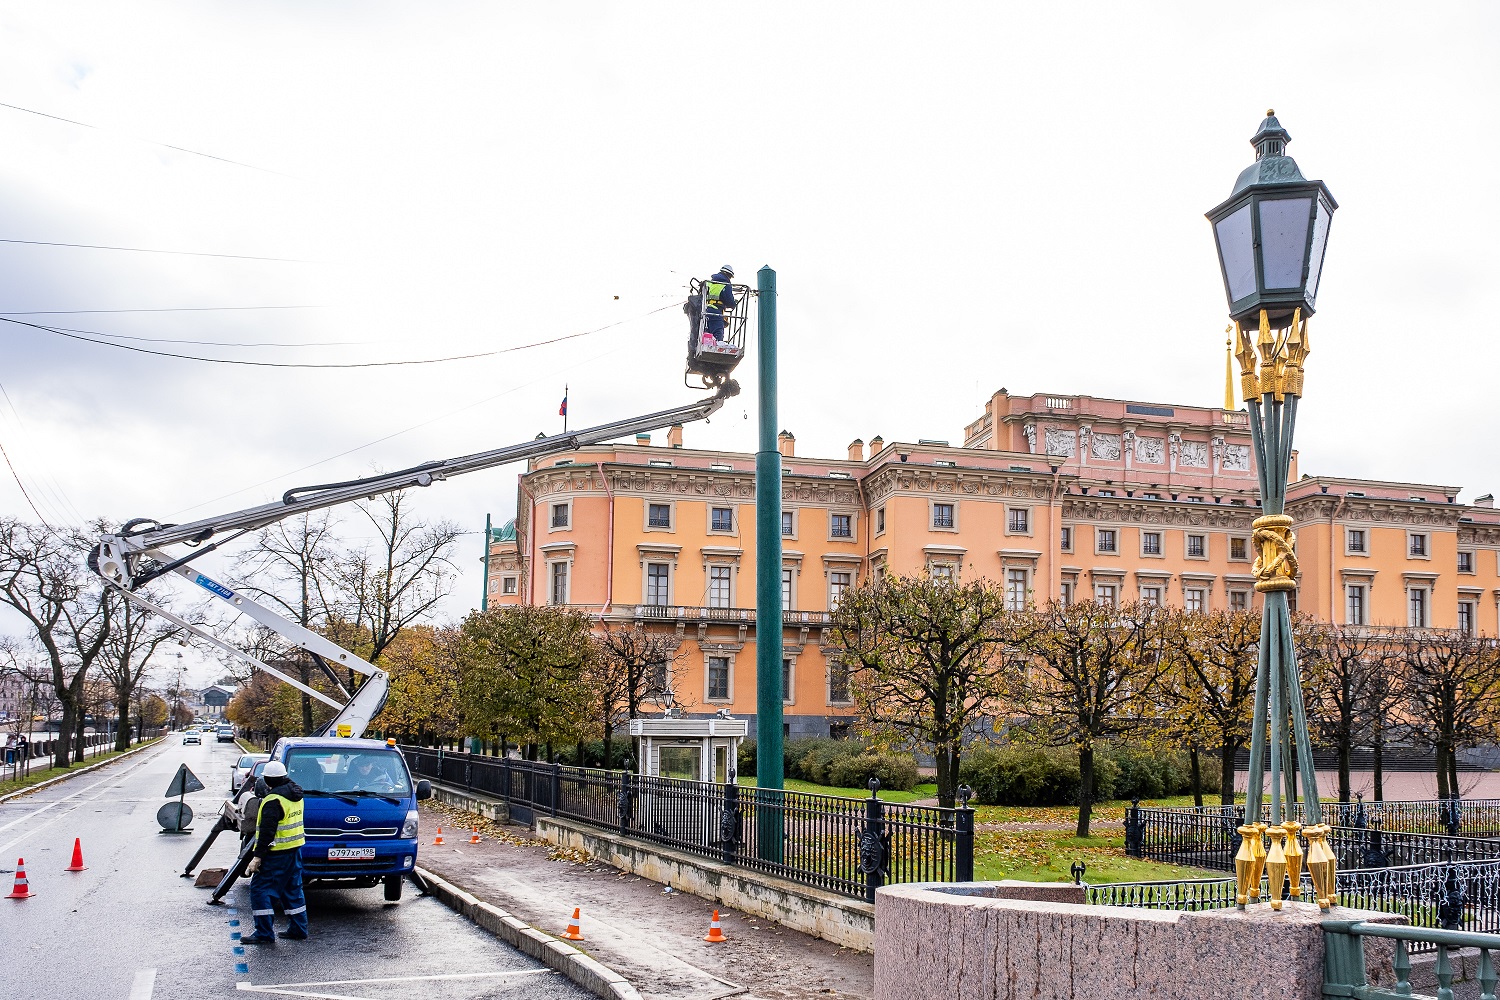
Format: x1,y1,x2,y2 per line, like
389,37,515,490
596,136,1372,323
755,267,783,862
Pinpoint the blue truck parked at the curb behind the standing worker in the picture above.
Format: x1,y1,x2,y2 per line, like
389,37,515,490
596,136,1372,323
272,736,432,903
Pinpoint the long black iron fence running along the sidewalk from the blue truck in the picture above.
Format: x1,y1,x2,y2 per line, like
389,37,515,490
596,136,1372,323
402,747,974,903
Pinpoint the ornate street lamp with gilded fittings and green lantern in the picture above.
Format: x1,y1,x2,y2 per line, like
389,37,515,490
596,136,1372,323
1208,111,1338,910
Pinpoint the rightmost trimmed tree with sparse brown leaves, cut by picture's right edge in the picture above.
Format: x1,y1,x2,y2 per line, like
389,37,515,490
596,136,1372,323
1394,628,1500,799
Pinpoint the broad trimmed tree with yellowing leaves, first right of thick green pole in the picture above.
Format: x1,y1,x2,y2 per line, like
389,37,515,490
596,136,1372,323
833,576,1026,807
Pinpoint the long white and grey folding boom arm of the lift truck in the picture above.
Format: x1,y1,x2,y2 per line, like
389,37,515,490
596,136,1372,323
89,381,740,736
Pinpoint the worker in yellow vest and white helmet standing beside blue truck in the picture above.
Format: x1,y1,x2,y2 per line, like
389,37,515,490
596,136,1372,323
240,760,308,945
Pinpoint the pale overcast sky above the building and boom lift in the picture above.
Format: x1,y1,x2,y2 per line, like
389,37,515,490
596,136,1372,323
0,0,1500,683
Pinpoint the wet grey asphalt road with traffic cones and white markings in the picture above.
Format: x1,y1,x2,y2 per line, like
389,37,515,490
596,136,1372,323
0,736,591,1000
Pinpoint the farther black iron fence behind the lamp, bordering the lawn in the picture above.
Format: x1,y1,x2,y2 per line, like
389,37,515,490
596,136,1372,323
1125,805,1500,871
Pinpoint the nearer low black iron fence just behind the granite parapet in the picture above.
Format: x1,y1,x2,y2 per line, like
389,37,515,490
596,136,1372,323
1085,861,1500,952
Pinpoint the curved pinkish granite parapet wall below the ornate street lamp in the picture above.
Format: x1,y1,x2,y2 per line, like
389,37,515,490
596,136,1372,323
875,883,1406,1000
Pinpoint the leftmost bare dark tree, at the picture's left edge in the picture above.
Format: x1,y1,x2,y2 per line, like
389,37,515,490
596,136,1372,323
0,517,111,768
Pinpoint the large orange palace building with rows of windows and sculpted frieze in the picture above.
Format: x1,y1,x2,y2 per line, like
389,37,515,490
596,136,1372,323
486,388,1500,736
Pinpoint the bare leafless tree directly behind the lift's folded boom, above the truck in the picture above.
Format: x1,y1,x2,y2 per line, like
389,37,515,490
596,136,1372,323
236,511,338,733
